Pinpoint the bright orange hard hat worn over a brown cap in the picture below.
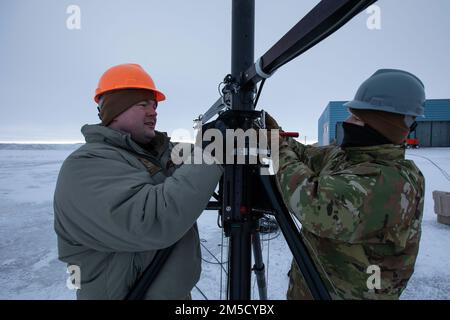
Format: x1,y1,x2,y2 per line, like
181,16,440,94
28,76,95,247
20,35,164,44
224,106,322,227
94,63,166,103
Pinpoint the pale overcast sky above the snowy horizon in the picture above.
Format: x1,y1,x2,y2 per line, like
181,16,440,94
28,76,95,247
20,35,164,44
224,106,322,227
0,0,450,141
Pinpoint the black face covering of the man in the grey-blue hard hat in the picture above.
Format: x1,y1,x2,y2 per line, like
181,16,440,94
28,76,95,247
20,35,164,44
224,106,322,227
341,122,392,148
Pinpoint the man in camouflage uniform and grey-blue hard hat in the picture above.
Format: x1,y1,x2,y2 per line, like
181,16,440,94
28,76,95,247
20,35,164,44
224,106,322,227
268,70,425,299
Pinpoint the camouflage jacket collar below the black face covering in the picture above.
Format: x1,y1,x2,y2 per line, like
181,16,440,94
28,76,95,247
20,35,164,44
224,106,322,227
343,144,405,163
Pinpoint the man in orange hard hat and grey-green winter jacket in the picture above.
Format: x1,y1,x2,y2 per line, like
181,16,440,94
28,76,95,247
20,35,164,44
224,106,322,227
54,64,223,299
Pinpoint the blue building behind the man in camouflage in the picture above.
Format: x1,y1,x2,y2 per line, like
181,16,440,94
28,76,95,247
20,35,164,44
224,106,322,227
317,99,450,147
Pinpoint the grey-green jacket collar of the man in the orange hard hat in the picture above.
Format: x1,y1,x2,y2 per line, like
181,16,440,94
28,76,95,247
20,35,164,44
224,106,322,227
81,124,170,159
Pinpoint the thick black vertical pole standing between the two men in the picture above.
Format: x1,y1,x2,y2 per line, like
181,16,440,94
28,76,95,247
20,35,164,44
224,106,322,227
227,0,255,300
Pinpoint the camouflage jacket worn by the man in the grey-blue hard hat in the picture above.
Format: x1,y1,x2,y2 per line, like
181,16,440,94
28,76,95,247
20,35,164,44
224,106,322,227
277,138,425,299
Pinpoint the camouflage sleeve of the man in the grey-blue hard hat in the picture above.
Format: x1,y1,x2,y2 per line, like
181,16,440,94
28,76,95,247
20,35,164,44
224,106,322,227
277,143,422,246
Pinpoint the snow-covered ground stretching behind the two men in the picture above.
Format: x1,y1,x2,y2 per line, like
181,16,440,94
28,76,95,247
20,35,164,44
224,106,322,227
0,145,450,299
